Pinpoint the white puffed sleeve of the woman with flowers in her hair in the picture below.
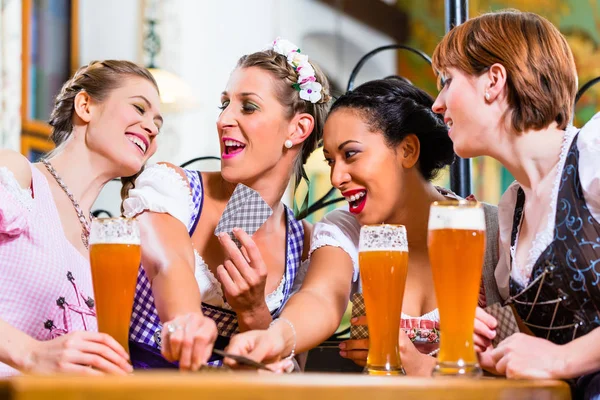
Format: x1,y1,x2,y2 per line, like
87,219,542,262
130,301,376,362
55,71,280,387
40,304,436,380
123,164,194,228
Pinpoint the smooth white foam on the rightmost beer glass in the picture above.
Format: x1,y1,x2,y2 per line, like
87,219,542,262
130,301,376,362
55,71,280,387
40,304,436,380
429,205,485,231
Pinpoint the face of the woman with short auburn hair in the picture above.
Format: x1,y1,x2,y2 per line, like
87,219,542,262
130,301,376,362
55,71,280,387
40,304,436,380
432,68,501,158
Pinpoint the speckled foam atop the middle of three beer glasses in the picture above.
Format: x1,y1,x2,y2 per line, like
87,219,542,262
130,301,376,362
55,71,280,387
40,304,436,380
358,225,408,252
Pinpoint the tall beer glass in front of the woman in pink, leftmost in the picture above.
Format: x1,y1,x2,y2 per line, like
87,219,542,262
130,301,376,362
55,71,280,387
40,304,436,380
90,218,141,351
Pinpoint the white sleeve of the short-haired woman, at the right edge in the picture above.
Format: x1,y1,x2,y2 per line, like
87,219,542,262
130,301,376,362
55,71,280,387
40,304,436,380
577,113,600,222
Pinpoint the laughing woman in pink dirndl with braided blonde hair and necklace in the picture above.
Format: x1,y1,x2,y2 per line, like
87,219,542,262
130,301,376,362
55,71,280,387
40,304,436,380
0,60,169,376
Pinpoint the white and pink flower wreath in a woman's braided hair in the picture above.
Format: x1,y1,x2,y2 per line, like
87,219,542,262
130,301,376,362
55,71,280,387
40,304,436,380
273,38,323,104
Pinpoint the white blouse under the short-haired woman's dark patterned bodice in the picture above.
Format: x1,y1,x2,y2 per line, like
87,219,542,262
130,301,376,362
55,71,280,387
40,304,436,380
495,113,600,299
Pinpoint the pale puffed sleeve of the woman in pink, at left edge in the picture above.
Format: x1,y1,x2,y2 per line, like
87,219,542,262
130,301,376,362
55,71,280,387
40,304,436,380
0,167,33,237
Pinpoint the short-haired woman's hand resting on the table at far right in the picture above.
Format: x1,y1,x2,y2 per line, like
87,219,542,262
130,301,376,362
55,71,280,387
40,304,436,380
490,333,567,379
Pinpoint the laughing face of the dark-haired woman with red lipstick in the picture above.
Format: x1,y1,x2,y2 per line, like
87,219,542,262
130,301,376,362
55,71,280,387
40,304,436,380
323,108,406,225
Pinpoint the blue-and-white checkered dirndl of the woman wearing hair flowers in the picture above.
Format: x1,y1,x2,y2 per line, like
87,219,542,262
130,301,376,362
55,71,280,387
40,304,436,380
129,170,304,368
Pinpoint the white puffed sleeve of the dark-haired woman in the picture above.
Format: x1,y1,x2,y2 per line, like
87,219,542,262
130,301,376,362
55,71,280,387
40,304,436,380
309,208,360,282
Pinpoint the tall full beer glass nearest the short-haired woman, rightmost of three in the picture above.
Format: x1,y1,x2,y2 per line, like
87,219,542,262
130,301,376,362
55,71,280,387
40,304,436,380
427,200,485,376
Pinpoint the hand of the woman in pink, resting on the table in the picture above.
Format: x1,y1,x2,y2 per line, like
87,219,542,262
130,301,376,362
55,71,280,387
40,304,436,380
22,331,133,375
